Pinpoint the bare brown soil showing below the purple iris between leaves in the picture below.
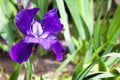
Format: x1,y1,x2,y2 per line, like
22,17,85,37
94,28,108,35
0,47,75,80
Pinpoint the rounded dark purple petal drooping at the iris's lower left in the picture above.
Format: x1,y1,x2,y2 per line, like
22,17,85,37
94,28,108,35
10,39,34,63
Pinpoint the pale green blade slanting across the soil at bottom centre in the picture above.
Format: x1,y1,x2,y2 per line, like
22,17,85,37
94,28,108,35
51,48,80,80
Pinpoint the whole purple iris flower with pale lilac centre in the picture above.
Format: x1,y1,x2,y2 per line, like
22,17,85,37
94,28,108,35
10,8,65,63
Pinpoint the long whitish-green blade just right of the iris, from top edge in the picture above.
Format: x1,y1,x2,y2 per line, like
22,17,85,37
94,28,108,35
56,0,75,53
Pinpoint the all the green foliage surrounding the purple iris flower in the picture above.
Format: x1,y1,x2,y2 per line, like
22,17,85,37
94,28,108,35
0,0,120,80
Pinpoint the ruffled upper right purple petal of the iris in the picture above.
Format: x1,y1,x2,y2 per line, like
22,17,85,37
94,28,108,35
41,9,63,34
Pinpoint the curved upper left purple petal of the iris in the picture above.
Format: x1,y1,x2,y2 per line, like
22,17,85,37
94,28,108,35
15,8,39,35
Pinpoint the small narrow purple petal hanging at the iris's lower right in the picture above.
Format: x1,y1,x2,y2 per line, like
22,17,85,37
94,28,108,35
52,41,65,61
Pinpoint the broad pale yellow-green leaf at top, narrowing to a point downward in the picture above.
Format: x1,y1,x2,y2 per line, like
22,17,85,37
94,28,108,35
76,0,94,37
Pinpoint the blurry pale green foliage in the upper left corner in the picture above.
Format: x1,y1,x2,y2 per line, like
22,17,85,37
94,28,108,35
0,0,16,47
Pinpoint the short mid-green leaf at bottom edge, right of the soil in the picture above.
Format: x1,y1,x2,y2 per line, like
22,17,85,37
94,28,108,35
72,60,84,80
